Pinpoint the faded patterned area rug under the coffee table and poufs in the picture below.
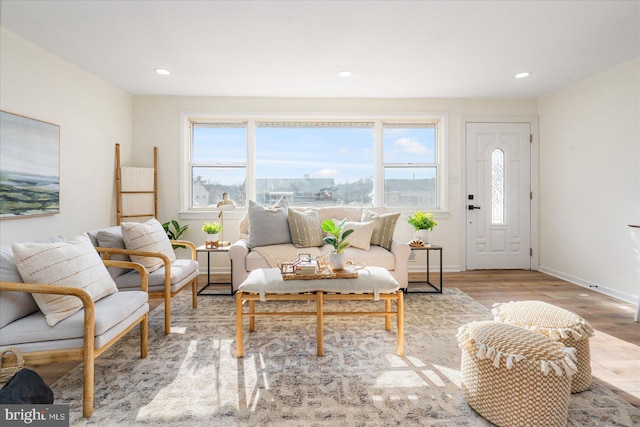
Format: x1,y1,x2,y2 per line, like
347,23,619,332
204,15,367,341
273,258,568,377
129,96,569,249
52,289,640,427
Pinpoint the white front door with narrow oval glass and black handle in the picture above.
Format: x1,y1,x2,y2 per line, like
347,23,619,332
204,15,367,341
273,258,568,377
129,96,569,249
465,123,531,270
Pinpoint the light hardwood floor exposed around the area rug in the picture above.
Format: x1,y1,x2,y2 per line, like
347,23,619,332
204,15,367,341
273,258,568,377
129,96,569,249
30,270,640,408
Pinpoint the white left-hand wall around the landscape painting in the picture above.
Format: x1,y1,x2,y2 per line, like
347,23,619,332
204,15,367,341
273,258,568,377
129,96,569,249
0,28,132,244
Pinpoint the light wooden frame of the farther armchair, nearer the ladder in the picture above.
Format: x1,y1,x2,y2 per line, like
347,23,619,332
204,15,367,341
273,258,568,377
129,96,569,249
96,240,198,335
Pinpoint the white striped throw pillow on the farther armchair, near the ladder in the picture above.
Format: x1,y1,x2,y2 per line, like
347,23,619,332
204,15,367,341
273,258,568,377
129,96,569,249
120,218,176,272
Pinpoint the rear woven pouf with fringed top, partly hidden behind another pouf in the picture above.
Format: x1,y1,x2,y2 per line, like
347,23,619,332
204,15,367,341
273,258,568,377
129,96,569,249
492,301,593,393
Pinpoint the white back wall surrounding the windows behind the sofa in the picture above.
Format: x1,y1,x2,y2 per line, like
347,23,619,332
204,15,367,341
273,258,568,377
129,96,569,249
133,96,537,270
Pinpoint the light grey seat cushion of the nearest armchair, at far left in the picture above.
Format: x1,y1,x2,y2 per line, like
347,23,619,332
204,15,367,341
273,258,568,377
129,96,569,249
0,291,149,346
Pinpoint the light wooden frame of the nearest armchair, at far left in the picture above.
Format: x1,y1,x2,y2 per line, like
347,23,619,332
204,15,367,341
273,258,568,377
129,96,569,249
0,260,149,418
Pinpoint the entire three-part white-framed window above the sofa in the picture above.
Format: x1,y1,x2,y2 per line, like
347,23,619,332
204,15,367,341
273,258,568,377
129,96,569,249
182,116,446,211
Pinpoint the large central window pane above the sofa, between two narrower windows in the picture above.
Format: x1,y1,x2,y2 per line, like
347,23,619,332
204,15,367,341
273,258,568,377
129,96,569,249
256,123,374,206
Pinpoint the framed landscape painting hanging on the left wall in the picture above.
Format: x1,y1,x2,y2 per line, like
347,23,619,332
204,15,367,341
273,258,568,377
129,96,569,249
0,111,60,219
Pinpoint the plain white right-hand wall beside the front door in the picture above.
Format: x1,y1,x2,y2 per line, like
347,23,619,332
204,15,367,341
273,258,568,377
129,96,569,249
538,58,640,302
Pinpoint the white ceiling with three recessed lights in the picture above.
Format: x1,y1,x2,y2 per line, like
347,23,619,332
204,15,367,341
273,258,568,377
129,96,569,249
0,0,640,98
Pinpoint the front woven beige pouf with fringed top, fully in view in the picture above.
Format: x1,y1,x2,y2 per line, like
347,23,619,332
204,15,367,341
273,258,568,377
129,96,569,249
457,321,575,427
